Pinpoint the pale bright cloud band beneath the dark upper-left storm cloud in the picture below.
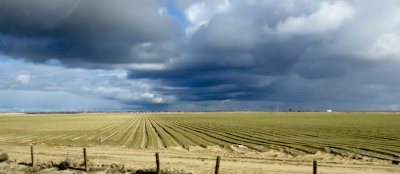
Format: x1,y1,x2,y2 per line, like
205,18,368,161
0,59,173,109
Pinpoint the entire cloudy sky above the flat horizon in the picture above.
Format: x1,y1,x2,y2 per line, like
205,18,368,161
0,0,400,112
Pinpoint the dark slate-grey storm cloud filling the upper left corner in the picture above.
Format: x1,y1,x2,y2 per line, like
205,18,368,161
0,0,177,64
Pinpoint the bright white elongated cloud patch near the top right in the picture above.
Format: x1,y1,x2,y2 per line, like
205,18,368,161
276,1,354,35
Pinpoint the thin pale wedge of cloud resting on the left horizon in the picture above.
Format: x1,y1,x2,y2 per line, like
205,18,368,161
0,89,122,111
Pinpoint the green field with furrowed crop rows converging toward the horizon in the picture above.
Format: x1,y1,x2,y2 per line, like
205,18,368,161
0,112,400,159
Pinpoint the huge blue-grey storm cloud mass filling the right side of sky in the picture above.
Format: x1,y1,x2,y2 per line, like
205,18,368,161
129,1,399,109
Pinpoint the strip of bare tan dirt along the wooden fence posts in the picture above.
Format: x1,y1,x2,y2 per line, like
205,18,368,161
0,144,400,174
